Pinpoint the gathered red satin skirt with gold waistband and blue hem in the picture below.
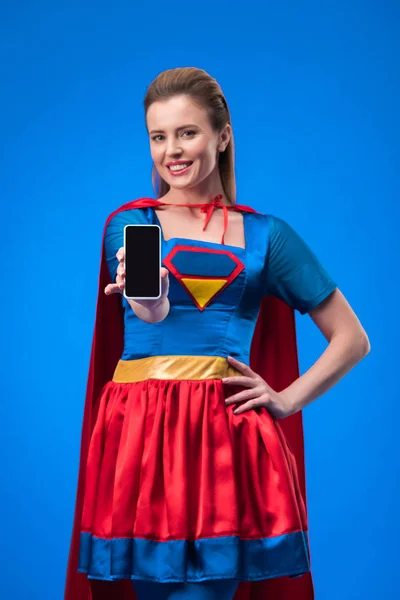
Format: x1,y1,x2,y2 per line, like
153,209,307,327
78,357,310,581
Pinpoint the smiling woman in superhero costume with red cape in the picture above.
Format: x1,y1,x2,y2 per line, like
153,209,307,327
65,68,369,600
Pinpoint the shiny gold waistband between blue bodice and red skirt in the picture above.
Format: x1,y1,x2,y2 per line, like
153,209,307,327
113,356,241,383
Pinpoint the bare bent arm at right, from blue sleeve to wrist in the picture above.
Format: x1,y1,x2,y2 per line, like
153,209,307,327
281,289,370,412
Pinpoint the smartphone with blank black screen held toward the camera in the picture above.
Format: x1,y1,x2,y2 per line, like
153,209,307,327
124,224,161,300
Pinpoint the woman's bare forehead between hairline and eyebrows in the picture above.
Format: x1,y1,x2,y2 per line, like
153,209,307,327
146,96,210,129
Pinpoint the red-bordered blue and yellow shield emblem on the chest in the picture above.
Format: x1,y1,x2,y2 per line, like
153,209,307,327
163,245,244,311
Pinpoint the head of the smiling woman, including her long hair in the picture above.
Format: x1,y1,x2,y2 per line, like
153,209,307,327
144,68,236,204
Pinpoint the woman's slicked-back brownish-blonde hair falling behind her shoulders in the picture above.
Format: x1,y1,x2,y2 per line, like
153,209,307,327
143,67,236,204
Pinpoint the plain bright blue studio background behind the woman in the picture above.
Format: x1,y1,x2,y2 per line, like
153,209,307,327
0,0,400,600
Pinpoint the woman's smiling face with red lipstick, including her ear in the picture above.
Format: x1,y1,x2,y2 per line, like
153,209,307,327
147,95,230,189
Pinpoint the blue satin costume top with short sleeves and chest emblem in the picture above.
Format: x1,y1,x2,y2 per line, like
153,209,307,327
105,207,336,364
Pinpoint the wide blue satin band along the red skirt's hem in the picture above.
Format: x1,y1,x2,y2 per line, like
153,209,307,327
78,531,310,582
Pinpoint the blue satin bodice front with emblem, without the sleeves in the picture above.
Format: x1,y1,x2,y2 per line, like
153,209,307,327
122,211,268,363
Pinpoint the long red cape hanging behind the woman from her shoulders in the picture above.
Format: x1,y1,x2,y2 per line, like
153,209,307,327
64,198,314,600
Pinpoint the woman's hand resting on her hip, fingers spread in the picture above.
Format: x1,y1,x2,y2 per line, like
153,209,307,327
222,356,297,419
